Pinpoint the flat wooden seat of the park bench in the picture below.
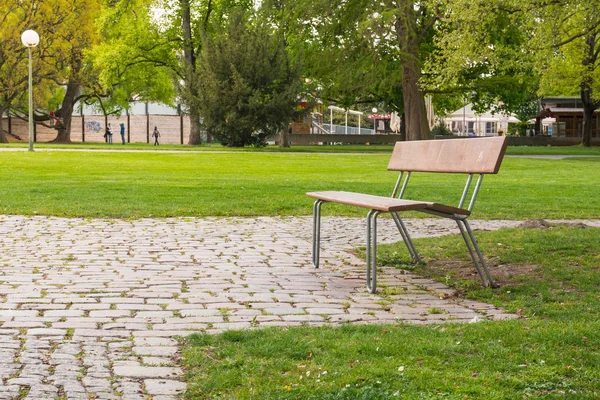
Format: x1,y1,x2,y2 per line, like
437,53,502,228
306,191,471,216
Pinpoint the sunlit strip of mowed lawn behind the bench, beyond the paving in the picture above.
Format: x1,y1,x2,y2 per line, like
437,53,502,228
0,150,600,219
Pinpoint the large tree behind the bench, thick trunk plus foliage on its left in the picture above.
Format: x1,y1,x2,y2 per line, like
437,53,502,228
282,0,442,140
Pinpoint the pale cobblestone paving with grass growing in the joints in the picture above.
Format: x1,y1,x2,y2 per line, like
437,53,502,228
0,216,600,400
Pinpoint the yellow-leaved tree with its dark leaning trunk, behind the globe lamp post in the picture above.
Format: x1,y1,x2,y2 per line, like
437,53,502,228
0,0,111,143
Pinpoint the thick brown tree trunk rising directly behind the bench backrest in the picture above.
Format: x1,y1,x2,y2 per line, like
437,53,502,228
396,1,431,140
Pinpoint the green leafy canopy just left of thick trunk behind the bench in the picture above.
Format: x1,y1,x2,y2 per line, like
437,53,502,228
276,0,402,110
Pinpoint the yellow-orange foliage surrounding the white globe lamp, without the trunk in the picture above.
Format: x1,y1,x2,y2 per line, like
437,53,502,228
0,0,90,142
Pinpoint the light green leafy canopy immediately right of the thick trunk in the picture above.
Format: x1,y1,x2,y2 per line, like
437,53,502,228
423,0,539,120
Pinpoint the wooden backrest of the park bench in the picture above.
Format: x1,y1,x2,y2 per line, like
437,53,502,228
388,136,508,174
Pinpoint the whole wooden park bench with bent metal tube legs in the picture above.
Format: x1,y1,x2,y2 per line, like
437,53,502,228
307,137,508,293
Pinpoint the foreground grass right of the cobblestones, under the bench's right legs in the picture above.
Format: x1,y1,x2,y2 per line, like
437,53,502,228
182,228,600,399
